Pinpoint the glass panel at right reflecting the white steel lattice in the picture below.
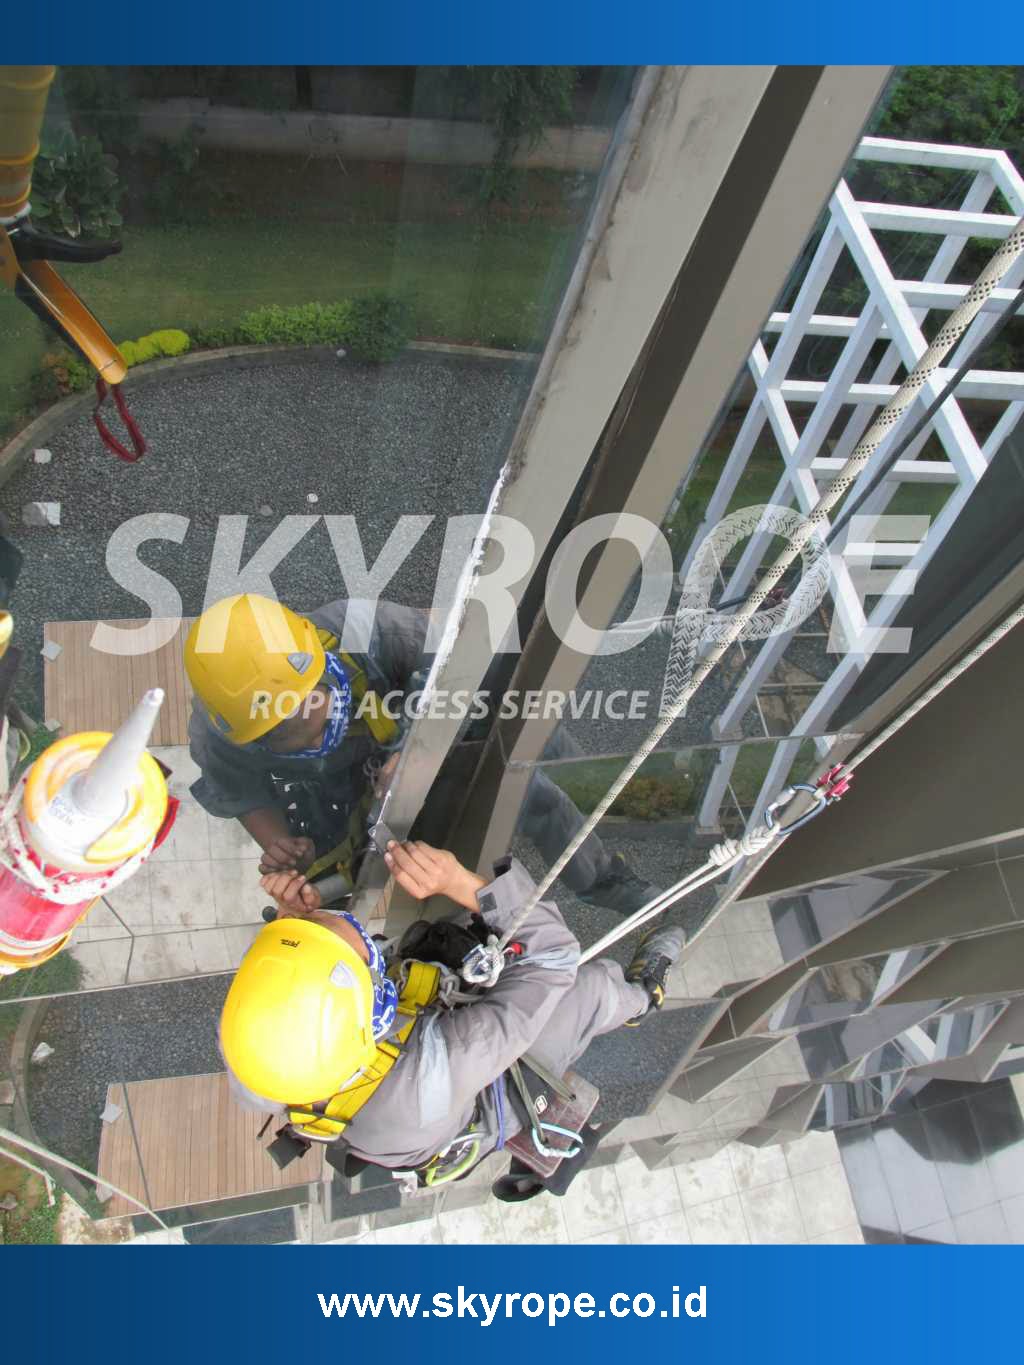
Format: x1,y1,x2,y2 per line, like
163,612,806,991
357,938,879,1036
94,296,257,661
532,68,1024,862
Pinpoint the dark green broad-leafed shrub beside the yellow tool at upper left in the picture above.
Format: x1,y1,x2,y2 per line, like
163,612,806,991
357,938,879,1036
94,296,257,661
31,130,124,238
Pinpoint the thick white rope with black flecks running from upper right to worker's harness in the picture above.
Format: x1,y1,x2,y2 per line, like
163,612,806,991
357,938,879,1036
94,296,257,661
501,218,1024,947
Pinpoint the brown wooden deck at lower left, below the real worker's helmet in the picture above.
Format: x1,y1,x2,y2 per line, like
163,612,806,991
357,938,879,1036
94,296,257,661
98,1072,324,1218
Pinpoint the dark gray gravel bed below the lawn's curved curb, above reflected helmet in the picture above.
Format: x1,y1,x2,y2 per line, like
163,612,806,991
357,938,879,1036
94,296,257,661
0,354,530,710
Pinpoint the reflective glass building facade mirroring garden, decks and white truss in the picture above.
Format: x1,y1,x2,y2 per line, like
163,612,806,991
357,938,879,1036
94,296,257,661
0,67,1024,1242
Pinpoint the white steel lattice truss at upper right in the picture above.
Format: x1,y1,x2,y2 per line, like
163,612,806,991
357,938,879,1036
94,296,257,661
693,138,1024,829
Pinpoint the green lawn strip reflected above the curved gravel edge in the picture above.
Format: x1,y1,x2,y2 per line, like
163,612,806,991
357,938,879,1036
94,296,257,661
0,220,575,430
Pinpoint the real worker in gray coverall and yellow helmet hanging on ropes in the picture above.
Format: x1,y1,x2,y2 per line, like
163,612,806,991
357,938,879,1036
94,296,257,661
220,841,684,1198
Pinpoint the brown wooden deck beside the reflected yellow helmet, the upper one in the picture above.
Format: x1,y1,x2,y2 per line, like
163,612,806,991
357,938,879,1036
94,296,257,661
42,617,194,745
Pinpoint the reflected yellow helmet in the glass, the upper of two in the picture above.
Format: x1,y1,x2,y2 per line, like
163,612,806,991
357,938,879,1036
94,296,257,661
184,592,324,744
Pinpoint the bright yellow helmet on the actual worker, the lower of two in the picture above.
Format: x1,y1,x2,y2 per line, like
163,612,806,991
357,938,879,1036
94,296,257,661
220,919,377,1104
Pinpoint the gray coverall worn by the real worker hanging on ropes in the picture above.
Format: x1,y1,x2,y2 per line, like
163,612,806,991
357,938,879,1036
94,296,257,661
233,860,650,1168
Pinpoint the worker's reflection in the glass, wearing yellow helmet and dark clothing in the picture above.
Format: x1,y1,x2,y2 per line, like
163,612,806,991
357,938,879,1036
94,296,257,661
184,592,657,915
